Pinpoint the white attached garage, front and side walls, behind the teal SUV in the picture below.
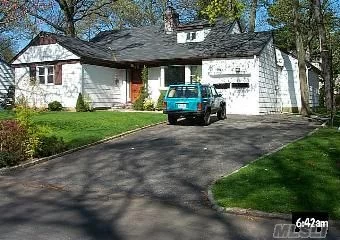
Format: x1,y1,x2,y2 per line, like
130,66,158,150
202,40,280,115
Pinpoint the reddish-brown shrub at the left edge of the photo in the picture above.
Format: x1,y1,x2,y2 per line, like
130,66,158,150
0,120,29,167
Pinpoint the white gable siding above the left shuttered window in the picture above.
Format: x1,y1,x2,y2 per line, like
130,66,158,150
13,43,79,64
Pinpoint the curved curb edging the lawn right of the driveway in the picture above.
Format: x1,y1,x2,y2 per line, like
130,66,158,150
208,128,322,223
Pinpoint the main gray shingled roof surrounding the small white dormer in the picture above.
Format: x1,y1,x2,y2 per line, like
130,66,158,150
92,21,272,62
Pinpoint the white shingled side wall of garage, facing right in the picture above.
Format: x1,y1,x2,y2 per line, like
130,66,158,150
259,41,280,114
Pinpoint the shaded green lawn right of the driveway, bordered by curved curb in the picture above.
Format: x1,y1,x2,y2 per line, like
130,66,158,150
212,129,340,219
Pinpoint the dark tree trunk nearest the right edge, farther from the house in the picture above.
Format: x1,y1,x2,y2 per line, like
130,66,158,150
312,0,334,111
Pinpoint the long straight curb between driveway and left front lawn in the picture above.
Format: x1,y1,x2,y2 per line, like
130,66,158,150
0,121,167,175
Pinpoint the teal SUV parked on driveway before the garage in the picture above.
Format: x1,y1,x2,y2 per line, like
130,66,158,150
163,83,226,125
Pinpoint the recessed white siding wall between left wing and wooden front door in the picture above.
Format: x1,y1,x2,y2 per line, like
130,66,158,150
83,64,127,107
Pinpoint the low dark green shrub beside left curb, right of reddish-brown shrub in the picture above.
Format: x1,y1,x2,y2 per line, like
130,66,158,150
34,135,66,157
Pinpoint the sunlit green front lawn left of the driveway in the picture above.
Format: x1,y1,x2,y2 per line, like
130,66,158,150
0,111,166,149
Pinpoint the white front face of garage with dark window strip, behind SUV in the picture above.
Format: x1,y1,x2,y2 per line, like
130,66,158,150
202,58,259,115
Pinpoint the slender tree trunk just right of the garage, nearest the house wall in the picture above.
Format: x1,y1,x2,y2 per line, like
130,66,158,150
293,0,311,116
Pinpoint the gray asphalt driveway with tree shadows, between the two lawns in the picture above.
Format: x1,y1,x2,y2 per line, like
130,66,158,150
0,116,335,240
